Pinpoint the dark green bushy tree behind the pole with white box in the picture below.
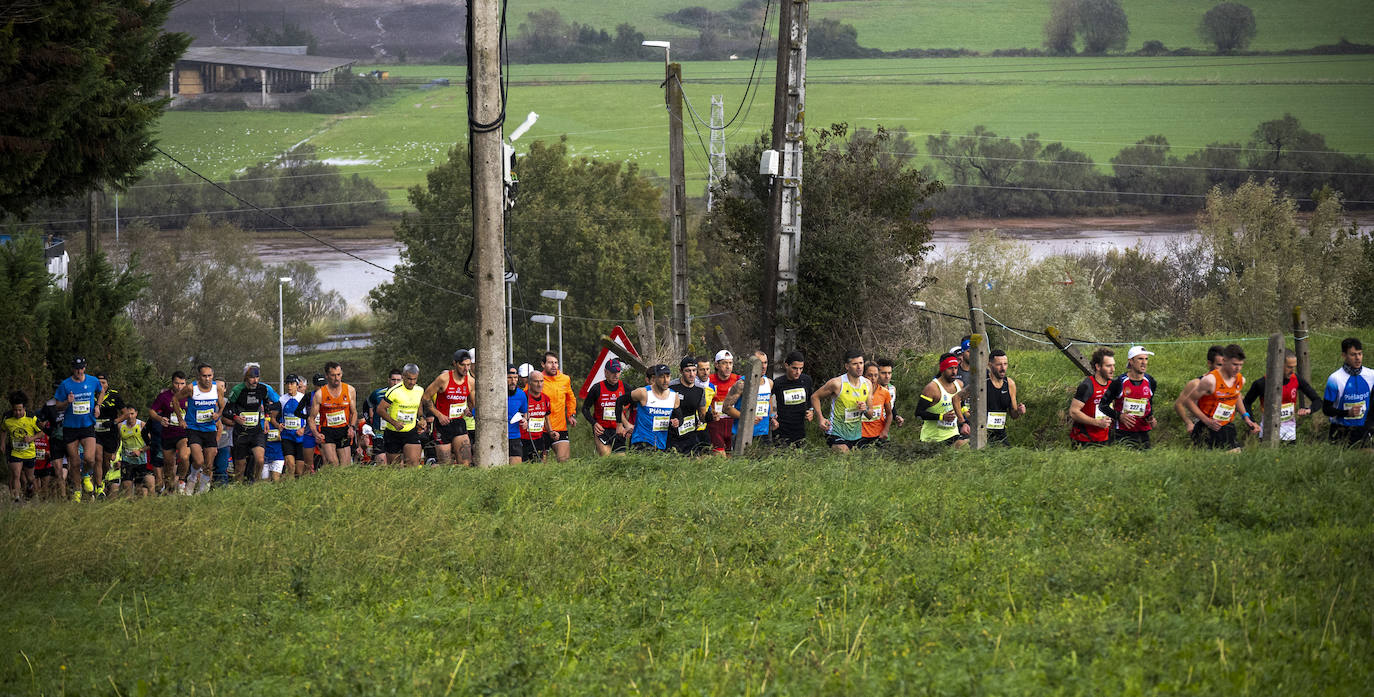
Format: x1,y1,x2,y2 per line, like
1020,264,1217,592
701,124,941,370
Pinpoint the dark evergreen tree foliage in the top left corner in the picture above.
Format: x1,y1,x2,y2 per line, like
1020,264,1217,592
0,0,191,214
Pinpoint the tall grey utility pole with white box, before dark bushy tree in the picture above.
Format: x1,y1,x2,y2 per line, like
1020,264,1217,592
758,0,809,366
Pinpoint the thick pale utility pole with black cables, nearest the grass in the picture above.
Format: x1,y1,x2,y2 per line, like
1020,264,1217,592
467,0,507,467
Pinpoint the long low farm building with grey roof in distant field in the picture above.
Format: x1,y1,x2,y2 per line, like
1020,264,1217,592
168,45,356,106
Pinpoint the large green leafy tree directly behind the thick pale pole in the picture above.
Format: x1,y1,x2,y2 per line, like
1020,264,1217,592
370,140,669,374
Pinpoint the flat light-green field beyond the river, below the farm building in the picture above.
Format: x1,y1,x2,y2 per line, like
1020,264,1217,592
150,56,1374,205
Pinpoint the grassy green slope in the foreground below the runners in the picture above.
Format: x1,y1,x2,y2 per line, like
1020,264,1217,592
0,448,1374,694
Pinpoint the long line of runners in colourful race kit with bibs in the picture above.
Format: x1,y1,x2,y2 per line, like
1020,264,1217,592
0,337,1374,500
